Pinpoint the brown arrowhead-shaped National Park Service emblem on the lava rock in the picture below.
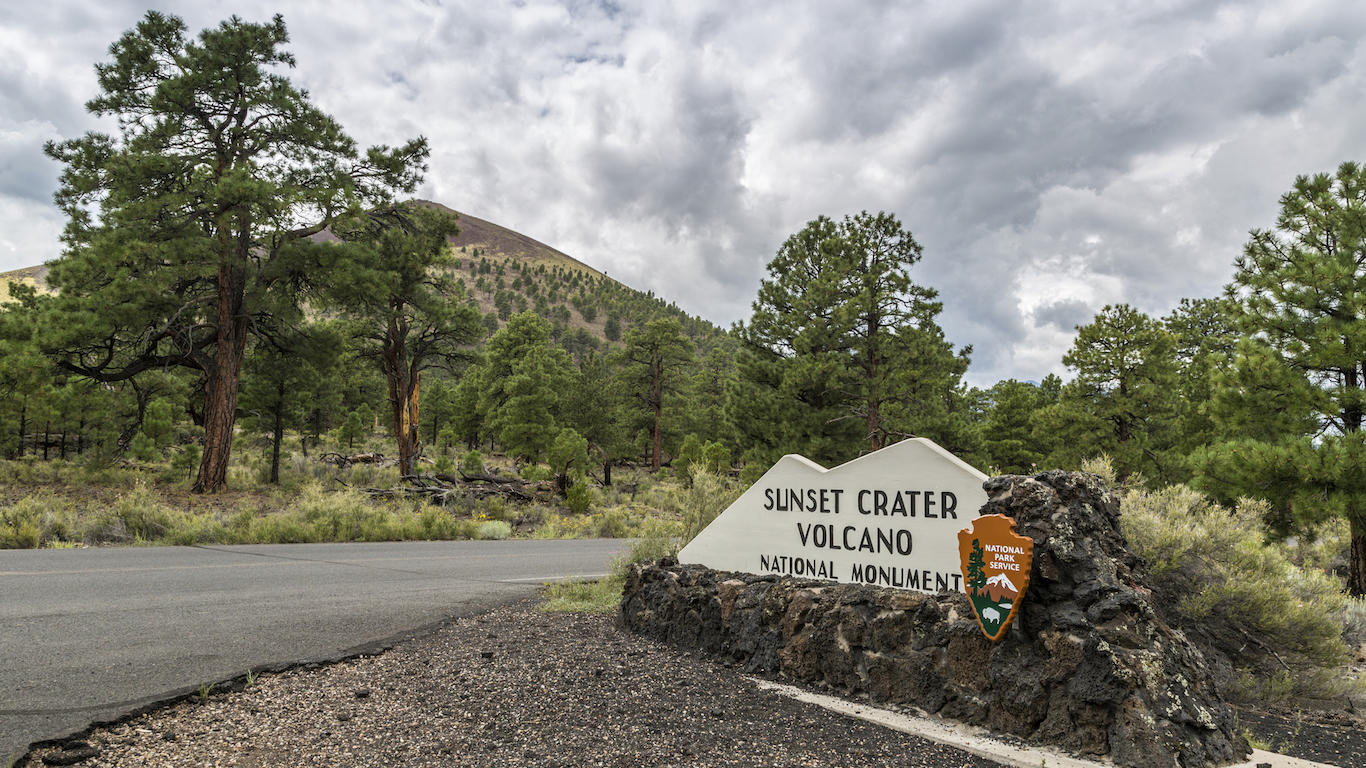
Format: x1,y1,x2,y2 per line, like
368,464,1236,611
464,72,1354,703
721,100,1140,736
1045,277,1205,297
958,515,1034,641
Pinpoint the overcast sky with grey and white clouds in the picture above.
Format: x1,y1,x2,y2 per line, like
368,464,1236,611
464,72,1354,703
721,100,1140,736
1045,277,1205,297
0,0,1366,387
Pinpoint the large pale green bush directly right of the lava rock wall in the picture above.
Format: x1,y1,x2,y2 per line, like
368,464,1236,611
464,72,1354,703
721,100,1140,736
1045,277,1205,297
1120,485,1348,697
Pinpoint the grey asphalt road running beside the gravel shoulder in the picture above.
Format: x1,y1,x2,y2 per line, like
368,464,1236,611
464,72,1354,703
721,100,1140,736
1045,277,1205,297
0,540,624,765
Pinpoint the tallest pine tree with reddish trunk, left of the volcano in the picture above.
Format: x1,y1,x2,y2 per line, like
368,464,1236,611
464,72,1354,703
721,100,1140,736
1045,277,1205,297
45,11,428,492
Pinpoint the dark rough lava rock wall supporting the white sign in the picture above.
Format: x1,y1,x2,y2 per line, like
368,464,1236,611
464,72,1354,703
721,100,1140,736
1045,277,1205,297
619,471,1251,768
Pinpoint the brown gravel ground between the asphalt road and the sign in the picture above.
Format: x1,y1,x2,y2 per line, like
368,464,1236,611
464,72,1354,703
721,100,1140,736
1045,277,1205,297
18,599,1366,768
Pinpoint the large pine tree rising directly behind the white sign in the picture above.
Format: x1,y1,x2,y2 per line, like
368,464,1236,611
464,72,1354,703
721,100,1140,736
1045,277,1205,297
732,212,971,461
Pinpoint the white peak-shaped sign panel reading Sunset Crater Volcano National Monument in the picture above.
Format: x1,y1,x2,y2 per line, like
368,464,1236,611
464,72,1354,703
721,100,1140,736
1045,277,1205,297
679,437,986,592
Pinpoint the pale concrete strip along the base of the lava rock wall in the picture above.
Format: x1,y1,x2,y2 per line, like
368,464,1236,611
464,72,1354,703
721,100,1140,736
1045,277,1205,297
750,678,1337,768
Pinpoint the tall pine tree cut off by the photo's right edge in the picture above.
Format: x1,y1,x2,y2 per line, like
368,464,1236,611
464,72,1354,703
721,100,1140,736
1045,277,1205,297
1197,163,1366,596
